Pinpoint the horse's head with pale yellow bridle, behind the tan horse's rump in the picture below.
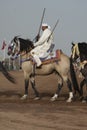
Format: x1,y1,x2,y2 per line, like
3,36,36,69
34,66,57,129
71,43,80,62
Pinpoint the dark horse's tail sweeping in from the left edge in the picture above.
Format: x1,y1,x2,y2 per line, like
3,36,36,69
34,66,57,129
0,62,16,83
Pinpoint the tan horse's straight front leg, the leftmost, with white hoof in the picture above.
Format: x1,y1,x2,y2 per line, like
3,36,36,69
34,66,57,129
21,72,29,99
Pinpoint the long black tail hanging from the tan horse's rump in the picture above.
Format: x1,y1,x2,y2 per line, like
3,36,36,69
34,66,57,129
70,57,80,95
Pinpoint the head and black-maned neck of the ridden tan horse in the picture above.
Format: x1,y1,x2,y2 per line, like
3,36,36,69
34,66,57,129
7,36,34,56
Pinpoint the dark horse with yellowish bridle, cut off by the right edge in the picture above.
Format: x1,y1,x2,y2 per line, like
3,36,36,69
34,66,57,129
71,42,87,102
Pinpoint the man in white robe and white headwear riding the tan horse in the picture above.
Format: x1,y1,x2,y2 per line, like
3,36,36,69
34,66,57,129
30,23,54,67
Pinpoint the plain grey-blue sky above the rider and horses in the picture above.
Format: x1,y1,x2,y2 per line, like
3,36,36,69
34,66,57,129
0,0,87,59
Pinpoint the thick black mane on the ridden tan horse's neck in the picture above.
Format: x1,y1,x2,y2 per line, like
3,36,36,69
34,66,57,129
18,38,34,53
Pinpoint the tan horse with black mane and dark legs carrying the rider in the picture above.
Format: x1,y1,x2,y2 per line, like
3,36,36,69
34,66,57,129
8,36,79,102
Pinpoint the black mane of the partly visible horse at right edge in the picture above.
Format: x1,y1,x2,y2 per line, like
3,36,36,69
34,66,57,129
78,42,87,61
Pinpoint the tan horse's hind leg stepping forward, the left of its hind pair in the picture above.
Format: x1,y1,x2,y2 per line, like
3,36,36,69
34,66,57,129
51,77,63,101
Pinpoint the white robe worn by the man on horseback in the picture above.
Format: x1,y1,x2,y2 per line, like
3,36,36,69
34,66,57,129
30,28,53,58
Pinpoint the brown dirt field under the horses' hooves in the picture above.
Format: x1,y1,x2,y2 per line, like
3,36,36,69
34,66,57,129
0,71,87,130
